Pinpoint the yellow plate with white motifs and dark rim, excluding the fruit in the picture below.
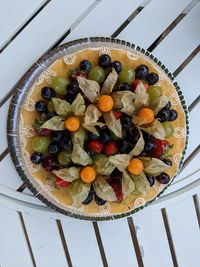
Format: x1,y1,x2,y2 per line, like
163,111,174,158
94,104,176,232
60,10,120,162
7,37,189,221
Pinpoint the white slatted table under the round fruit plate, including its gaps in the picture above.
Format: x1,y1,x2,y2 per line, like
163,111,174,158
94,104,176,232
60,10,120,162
0,0,200,267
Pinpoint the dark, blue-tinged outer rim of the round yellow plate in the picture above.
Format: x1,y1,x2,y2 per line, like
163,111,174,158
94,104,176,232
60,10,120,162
7,37,189,221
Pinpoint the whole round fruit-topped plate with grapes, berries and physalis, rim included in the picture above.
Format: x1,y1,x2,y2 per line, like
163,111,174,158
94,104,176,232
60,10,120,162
8,38,188,220
